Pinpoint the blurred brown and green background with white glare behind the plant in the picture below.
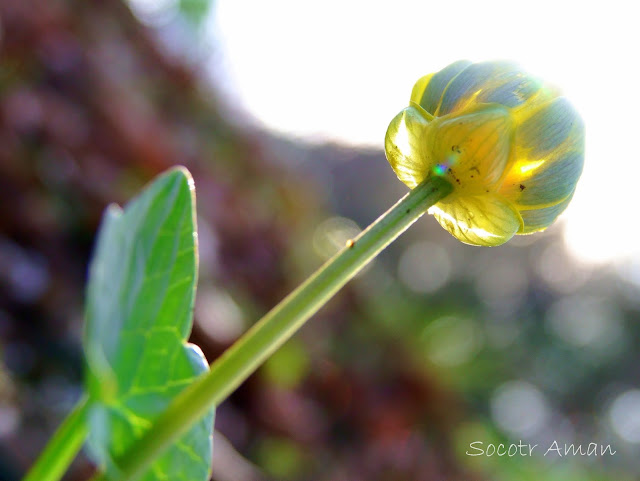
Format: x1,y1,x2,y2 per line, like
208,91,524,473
0,0,640,481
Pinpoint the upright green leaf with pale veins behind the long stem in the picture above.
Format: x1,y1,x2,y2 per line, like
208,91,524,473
84,168,214,481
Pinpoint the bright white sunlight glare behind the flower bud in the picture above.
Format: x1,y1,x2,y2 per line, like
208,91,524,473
211,0,640,262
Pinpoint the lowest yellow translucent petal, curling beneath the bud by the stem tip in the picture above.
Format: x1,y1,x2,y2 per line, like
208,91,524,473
429,194,522,246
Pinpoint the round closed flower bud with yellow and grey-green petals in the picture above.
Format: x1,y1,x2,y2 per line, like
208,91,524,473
385,61,584,246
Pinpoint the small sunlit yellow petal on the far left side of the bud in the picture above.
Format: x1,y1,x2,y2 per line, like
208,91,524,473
384,107,429,189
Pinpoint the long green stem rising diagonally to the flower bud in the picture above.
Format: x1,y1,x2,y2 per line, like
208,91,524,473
95,177,452,481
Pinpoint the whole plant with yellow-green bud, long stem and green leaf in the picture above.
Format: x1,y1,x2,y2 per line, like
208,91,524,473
25,61,584,481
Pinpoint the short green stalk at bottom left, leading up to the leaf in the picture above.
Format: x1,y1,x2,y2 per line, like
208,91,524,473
22,397,89,481
